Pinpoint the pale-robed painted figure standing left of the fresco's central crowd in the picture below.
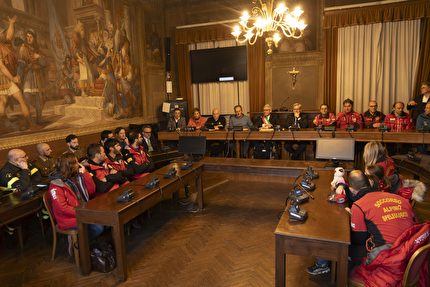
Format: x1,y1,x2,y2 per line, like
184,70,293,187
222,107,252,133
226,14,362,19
71,22,94,97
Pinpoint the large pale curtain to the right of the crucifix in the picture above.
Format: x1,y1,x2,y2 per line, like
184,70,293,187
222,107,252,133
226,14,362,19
336,20,420,114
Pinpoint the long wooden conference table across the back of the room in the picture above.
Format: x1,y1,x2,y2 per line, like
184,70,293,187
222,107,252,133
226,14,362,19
158,128,430,158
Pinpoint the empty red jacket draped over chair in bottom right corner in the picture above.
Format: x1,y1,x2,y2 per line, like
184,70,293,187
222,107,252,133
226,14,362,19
356,222,430,287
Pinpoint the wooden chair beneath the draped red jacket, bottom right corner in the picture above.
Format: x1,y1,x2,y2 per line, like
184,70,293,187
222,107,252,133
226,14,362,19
348,244,430,287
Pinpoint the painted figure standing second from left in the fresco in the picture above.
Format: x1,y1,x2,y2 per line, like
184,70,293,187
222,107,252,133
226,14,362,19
17,29,49,123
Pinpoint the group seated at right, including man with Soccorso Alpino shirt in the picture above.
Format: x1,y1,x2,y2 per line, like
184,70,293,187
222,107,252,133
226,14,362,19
307,141,429,286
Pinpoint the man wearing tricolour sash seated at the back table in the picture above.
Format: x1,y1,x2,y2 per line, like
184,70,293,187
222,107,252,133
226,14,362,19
254,105,281,159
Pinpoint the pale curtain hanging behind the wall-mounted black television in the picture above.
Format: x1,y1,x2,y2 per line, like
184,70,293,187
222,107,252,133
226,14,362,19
188,39,249,115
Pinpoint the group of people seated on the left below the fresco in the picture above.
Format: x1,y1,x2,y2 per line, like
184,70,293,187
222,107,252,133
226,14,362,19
0,125,159,252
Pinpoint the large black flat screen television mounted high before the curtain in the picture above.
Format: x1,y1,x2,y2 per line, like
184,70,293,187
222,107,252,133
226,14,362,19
190,46,248,84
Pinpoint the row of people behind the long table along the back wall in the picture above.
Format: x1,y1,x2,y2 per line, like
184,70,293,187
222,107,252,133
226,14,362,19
167,83,430,160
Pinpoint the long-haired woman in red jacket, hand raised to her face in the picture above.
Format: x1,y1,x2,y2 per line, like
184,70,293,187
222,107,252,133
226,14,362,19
49,152,105,253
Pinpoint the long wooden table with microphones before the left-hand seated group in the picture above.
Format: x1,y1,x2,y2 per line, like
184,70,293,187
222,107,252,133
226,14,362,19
75,163,203,282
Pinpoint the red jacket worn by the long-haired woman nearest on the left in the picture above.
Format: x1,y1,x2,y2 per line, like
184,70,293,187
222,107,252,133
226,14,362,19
49,171,96,230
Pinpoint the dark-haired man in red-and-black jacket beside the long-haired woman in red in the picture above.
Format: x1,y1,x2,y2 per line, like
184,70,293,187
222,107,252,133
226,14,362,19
85,144,129,197
